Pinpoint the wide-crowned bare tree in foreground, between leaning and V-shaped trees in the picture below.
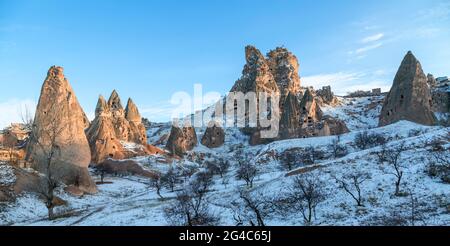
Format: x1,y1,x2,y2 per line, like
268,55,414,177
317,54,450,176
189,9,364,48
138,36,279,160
276,174,325,224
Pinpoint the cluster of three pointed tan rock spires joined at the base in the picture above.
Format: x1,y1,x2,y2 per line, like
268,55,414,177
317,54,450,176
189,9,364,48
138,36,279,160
86,90,165,164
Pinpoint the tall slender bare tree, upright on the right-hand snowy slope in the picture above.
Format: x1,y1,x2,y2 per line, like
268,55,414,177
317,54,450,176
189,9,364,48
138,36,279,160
385,142,405,196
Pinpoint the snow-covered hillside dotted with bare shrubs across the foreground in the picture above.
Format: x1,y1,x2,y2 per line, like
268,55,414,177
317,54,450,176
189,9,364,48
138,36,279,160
0,97,450,225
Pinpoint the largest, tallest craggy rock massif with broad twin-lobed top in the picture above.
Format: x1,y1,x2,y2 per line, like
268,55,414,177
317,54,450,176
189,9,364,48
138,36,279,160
227,46,348,145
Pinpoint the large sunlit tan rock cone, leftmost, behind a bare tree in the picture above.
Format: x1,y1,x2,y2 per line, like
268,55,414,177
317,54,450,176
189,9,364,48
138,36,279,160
27,66,97,193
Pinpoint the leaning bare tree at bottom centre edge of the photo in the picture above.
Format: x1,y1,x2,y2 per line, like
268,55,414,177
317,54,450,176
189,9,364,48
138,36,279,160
231,189,274,226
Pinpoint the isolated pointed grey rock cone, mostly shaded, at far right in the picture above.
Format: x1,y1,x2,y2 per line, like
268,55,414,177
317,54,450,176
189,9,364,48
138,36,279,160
379,51,436,126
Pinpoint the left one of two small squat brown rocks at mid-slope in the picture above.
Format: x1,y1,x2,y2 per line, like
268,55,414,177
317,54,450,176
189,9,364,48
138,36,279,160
166,125,197,156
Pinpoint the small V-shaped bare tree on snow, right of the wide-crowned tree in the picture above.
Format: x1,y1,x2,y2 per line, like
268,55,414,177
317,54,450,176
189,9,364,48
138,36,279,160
334,172,370,206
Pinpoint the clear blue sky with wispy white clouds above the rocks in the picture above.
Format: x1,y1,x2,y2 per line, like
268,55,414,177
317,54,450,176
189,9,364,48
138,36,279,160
0,0,450,125
